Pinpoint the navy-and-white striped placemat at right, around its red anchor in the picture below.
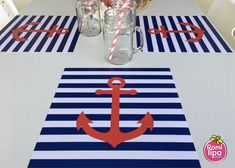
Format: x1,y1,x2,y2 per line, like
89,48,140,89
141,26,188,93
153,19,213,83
136,16,232,53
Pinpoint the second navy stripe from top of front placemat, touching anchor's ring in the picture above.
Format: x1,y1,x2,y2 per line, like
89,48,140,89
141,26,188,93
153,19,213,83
61,75,172,79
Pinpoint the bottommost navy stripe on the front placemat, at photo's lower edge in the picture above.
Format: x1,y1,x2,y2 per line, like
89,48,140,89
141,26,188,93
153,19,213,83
28,159,201,168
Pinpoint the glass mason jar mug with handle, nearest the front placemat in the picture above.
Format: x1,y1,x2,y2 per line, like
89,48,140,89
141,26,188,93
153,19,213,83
103,9,143,65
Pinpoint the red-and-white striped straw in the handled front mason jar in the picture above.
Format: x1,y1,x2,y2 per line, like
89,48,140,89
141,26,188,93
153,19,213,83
108,0,129,60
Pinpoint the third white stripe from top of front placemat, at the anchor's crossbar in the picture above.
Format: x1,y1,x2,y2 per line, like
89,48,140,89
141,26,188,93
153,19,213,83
56,88,177,93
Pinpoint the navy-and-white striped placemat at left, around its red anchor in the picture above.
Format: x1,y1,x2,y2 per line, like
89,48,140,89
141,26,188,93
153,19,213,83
0,15,79,52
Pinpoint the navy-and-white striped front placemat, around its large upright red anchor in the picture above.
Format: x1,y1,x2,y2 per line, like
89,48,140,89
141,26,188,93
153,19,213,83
29,68,200,168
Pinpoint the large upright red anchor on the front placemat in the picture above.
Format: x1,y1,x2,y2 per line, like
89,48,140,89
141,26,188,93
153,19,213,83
76,77,154,148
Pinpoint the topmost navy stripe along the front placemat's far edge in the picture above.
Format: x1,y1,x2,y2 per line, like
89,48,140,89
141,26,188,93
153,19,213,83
64,68,171,72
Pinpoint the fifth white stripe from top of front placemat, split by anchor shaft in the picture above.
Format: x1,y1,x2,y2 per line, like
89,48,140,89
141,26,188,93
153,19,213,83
48,108,184,115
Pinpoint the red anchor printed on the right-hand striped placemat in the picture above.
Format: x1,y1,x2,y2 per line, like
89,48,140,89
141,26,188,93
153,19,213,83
148,22,205,42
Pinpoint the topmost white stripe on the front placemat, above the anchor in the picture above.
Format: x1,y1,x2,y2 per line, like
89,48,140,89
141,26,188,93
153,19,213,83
63,71,171,75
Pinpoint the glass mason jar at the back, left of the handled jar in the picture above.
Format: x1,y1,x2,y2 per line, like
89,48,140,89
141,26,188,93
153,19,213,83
76,0,101,37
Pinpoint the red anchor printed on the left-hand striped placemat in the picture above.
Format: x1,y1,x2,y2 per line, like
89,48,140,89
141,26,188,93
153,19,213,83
12,22,69,42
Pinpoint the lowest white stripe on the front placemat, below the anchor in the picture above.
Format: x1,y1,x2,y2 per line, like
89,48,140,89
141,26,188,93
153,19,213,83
32,151,198,160
